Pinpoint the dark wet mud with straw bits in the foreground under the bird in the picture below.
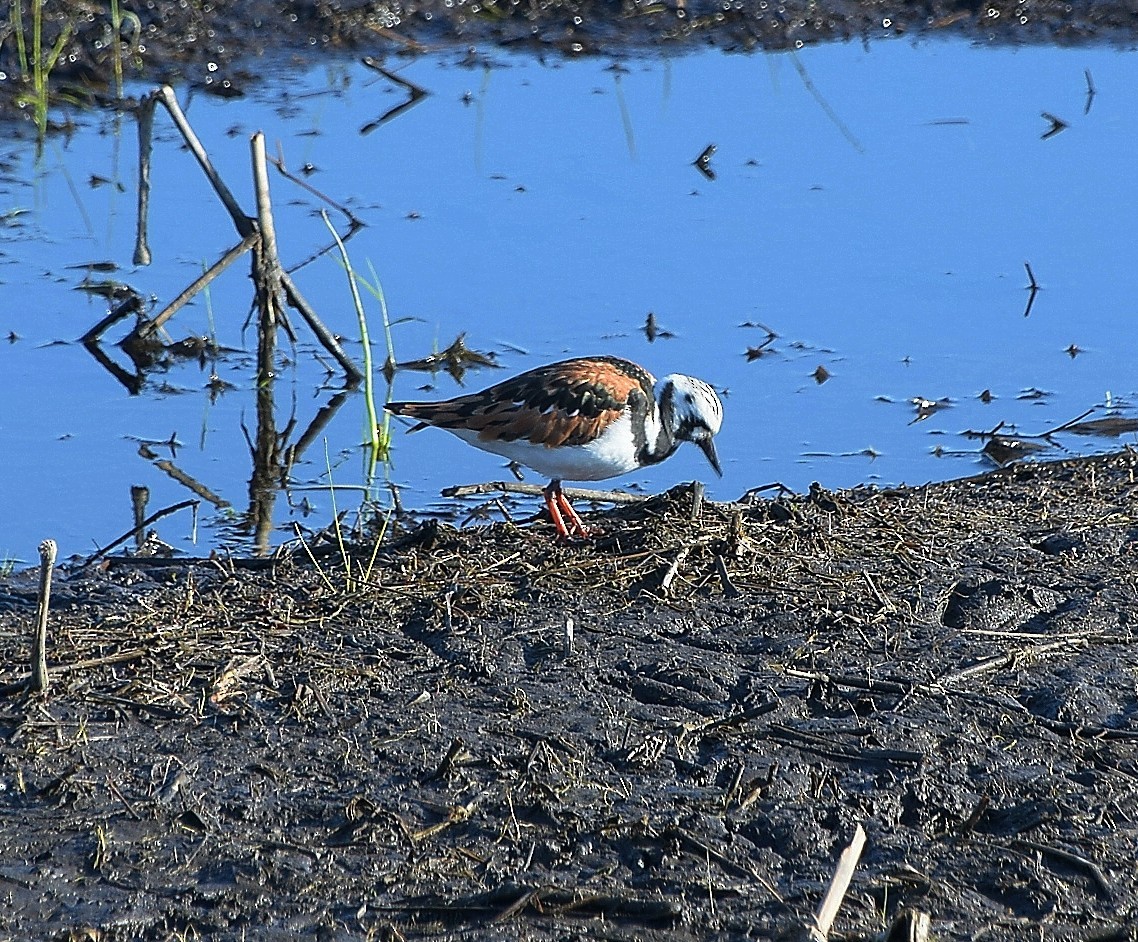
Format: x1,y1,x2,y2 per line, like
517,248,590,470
0,452,1138,940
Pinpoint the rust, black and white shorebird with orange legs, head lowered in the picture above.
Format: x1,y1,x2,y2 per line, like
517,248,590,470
385,356,723,538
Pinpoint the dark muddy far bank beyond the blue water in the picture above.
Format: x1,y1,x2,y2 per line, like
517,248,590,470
0,0,1138,118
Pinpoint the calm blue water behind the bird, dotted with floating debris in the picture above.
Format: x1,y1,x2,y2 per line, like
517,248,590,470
0,41,1138,561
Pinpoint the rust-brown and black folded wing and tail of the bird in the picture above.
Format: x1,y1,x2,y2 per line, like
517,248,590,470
387,357,653,448
